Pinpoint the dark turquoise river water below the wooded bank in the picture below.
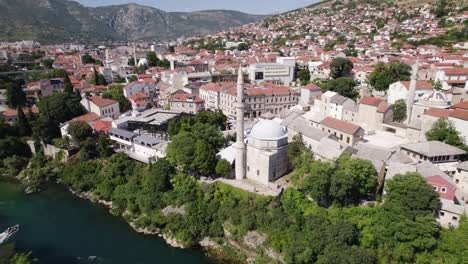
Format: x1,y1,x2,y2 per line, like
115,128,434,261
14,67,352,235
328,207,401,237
0,181,212,264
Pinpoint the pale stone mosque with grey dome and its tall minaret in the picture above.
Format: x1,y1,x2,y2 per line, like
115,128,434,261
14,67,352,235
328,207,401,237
233,68,289,186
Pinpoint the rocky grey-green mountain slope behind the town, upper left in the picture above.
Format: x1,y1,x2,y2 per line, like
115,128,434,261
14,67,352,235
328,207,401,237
0,0,263,43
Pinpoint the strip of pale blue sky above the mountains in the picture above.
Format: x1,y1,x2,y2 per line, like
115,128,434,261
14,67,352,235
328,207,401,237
76,0,318,14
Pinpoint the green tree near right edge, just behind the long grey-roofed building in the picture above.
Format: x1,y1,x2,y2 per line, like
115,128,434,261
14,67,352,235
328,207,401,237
426,118,467,149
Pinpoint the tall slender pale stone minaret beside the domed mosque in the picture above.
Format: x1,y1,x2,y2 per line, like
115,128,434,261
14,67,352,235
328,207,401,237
234,66,246,180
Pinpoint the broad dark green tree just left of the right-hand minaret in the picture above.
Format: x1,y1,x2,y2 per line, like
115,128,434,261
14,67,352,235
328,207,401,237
367,61,411,91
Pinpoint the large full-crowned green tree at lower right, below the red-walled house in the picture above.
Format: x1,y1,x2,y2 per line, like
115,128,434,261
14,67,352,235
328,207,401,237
362,173,440,263
